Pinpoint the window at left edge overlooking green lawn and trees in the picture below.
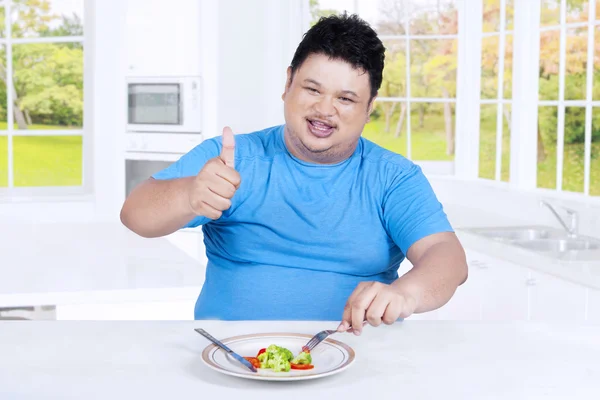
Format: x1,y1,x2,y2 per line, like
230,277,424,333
0,0,87,194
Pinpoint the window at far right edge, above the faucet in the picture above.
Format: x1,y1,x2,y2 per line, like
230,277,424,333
537,0,600,196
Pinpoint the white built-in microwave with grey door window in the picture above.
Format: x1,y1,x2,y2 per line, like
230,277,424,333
126,76,202,133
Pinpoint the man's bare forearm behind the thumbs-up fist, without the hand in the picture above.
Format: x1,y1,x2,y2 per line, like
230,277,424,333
121,177,196,237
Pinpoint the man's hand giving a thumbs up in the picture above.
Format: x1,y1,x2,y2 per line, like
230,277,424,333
188,126,241,220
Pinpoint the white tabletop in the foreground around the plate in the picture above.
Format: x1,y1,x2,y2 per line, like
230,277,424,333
0,321,600,400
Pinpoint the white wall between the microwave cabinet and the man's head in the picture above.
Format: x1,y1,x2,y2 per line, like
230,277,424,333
217,0,304,134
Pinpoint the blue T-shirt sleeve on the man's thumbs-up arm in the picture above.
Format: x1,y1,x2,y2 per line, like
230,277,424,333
152,137,221,228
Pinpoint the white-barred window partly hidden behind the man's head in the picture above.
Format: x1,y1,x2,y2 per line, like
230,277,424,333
310,0,458,174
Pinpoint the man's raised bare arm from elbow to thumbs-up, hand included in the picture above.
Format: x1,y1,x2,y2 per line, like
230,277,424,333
121,127,240,238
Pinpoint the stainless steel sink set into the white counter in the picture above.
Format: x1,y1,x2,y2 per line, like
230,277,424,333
462,225,600,261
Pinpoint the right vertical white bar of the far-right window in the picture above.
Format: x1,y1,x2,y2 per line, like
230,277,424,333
583,1,596,195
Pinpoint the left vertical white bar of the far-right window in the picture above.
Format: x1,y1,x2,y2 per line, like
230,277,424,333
556,0,567,192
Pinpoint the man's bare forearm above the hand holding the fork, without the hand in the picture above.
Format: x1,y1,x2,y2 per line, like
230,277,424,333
392,241,468,313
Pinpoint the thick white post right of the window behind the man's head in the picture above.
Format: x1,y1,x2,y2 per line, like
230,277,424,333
454,0,483,179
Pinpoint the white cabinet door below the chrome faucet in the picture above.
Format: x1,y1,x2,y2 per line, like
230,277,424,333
529,271,586,322
